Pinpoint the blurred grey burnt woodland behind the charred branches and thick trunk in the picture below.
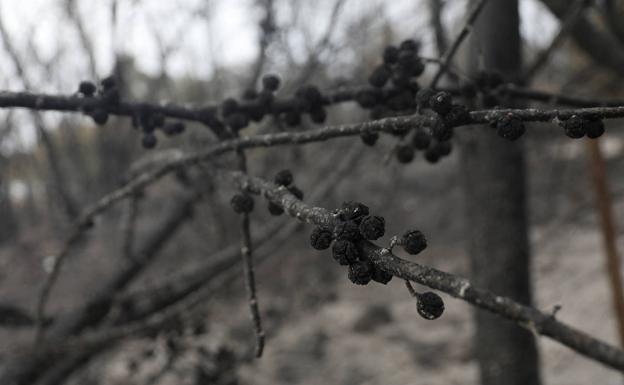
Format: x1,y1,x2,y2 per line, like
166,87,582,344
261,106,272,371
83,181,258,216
0,0,624,385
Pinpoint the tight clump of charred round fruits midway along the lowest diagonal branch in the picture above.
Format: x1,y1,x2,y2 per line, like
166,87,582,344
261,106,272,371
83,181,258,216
310,202,392,285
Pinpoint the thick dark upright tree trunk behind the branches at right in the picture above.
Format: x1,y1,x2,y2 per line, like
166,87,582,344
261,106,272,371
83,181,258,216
461,0,540,385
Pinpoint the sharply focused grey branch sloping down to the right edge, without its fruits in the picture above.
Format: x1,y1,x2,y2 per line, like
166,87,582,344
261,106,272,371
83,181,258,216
232,172,624,370
